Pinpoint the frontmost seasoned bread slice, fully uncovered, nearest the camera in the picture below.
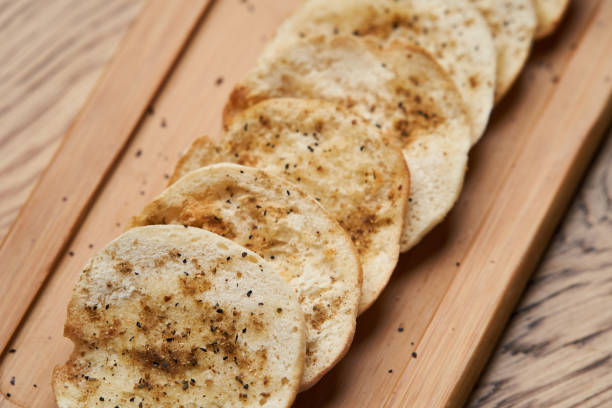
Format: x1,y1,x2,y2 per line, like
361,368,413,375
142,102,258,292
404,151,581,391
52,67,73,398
53,226,305,408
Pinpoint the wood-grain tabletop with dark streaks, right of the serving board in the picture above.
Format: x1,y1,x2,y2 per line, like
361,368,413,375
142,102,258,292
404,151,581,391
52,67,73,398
469,122,612,408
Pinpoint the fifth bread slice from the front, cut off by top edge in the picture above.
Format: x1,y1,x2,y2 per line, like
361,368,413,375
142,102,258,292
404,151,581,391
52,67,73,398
268,0,497,143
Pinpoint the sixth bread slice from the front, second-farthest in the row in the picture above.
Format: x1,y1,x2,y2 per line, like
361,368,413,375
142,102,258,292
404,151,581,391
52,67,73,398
470,0,537,102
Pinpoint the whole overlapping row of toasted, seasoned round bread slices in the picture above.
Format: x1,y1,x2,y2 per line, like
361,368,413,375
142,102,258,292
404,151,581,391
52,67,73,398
52,0,569,408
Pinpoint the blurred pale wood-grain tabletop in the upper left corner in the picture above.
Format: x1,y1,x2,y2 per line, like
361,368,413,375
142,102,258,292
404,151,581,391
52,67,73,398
0,0,143,240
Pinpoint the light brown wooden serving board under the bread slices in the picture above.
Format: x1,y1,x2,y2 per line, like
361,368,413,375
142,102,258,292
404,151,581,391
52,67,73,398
0,0,612,407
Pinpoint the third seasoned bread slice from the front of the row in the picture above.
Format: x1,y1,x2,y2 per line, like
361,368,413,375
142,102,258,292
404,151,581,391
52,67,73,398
172,99,410,312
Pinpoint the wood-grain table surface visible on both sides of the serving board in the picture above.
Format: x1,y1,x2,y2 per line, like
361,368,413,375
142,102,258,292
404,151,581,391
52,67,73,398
0,0,612,407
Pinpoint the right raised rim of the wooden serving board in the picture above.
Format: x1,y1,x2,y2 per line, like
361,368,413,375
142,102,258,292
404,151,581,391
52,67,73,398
390,2,612,407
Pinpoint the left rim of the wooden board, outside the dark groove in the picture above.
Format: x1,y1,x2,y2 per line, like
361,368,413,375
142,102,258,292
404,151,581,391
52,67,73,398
0,0,212,353
